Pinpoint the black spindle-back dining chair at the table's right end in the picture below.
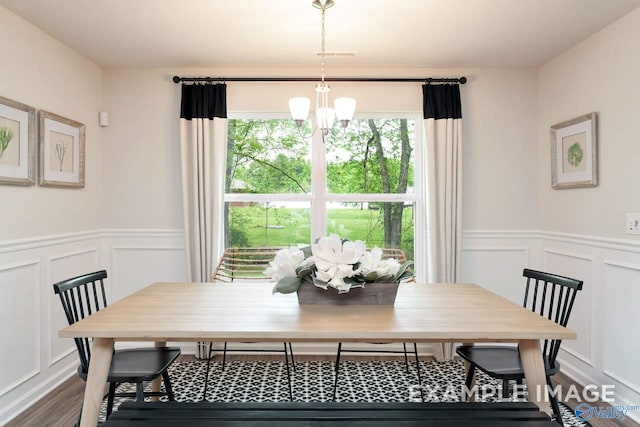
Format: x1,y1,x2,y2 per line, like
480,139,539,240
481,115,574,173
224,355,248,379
456,269,583,425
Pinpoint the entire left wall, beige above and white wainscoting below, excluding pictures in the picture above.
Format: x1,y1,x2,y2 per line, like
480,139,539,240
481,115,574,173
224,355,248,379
0,7,103,424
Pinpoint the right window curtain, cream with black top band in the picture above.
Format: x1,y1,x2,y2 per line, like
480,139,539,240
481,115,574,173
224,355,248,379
423,85,462,361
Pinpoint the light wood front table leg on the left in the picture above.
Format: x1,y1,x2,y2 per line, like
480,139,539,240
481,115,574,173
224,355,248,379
80,338,113,427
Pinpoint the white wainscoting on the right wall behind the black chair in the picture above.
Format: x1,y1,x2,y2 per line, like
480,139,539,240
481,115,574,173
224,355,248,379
540,232,640,422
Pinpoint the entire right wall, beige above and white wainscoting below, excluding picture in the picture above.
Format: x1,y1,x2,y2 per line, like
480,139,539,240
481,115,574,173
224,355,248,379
538,9,640,420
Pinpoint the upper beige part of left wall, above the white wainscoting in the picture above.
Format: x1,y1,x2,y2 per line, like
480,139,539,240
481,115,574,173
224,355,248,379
0,7,103,240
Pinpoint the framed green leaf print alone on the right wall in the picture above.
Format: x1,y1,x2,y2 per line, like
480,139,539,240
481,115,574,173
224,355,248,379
551,113,598,189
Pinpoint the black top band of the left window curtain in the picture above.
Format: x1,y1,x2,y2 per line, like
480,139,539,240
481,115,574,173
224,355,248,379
180,83,227,120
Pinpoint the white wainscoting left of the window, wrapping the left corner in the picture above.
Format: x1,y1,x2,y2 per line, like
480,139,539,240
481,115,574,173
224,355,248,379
0,230,186,425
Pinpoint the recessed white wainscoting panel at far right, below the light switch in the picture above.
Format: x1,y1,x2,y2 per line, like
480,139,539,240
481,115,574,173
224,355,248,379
602,261,640,393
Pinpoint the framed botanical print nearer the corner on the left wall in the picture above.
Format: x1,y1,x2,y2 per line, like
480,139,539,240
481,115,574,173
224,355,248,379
40,110,85,188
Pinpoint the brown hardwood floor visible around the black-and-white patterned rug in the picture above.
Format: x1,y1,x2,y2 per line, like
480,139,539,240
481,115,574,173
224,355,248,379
6,355,640,427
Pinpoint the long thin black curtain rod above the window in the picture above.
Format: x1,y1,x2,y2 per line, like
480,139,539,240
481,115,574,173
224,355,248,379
173,76,467,84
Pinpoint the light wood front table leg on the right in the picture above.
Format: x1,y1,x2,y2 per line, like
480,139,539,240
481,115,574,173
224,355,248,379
519,340,551,416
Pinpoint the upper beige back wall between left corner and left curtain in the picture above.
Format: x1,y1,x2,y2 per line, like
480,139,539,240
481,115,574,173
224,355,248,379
102,70,183,230
